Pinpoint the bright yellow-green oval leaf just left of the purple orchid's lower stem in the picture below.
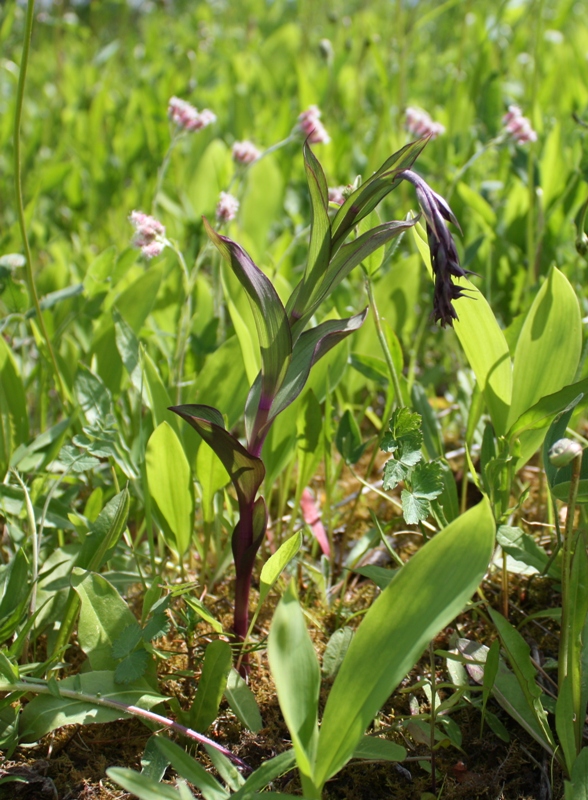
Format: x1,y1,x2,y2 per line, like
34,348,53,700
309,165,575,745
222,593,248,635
145,422,194,556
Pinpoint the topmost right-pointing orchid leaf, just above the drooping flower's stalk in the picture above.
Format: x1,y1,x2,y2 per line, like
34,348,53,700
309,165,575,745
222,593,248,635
331,139,428,253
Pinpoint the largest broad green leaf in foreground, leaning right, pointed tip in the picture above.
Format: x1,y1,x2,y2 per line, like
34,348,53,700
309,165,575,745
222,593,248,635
314,500,495,786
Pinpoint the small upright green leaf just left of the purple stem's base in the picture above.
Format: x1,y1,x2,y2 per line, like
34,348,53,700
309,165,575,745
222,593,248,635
189,639,233,736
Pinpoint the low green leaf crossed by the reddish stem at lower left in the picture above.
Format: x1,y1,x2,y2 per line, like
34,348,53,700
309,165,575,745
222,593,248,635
20,670,165,742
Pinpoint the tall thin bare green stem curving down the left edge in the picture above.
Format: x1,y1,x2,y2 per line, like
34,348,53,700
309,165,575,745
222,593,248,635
14,0,67,406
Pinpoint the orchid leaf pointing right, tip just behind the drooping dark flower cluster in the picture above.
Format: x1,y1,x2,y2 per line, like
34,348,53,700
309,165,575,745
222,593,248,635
290,217,418,341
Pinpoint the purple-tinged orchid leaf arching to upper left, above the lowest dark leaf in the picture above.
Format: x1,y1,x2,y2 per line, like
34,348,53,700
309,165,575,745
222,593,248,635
204,218,292,400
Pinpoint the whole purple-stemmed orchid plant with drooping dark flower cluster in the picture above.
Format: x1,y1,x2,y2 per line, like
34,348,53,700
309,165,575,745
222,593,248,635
170,138,467,663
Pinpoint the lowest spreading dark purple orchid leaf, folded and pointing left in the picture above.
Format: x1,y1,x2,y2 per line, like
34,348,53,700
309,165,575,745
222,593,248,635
170,405,265,503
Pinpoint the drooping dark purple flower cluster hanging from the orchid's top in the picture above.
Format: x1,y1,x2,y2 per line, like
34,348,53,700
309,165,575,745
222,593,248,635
399,170,472,327
